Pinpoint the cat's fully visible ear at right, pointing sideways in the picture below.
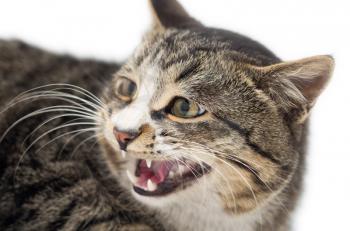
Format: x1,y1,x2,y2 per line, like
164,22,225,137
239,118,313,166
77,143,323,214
257,55,334,122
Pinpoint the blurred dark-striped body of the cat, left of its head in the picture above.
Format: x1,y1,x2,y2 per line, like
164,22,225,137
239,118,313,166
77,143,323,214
0,40,163,230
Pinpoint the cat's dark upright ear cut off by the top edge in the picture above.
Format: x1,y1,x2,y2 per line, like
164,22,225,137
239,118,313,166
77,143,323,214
149,0,201,30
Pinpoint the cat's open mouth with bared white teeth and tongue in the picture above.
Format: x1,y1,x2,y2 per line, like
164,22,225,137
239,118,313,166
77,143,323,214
127,159,211,196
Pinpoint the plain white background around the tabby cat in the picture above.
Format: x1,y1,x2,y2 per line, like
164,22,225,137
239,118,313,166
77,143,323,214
0,0,350,231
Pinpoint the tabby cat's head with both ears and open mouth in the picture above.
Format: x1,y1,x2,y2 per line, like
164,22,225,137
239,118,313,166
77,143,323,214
100,0,333,213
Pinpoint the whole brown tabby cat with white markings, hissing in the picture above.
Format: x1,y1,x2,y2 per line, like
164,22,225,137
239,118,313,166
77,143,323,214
0,0,334,231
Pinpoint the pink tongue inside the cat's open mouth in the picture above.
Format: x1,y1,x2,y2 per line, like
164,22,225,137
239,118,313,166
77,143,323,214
137,160,172,187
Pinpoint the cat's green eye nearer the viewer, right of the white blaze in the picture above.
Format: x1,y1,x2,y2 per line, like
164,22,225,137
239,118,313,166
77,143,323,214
169,98,206,118
